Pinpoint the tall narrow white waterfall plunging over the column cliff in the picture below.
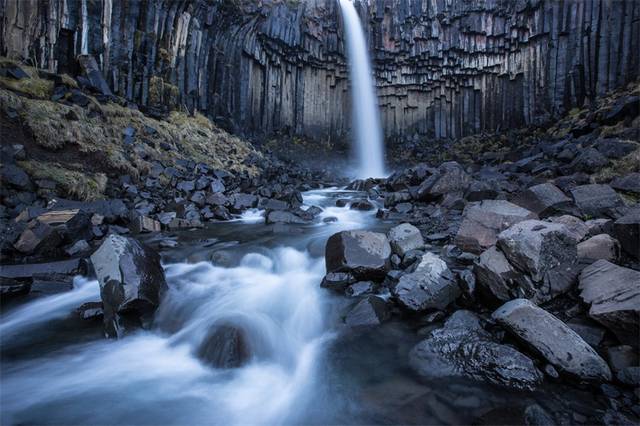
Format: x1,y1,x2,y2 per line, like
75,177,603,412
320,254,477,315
339,0,385,178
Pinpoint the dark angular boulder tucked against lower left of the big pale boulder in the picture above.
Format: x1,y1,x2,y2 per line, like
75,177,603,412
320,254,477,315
474,246,537,302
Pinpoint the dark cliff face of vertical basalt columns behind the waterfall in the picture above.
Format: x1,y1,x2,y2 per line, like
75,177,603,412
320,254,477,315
0,0,640,139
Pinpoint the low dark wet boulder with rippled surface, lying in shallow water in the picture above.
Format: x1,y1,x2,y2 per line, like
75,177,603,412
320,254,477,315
409,311,542,390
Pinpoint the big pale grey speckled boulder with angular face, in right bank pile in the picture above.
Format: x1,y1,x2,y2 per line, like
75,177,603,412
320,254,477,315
498,220,578,282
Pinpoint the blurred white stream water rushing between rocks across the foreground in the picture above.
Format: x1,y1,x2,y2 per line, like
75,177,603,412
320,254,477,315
0,190,608,425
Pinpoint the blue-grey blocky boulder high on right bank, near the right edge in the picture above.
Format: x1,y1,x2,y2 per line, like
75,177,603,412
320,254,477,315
571,184,624,219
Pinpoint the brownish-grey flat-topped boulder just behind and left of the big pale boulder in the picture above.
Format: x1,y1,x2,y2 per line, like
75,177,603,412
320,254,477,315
454,200,538,254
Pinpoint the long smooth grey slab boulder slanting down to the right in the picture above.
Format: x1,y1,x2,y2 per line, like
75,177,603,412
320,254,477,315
492,299,611,380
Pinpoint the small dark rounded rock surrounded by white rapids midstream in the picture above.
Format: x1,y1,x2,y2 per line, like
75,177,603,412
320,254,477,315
198,324,251,368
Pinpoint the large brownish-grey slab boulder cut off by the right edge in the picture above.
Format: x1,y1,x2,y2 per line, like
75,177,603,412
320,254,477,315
579,260,640,347
